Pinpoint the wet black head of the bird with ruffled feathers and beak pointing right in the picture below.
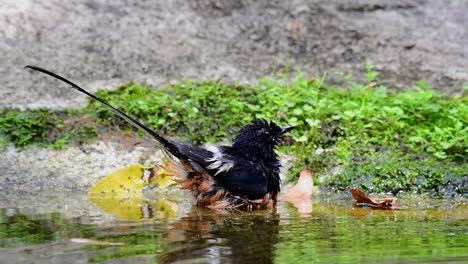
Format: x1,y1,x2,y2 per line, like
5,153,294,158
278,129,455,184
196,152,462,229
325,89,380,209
233,119,295,159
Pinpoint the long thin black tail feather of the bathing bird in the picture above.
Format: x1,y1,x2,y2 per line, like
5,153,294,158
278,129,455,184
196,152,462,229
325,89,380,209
25,65,188,162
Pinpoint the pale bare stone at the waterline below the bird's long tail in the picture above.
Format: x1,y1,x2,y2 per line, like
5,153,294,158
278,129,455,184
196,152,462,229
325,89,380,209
0,141,162,193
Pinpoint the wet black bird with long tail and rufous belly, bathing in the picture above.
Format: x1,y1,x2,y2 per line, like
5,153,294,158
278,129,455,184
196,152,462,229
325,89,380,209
25,65,295,211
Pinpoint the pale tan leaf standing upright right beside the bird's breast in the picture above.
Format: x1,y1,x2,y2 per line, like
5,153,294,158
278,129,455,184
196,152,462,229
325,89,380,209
283,170,314,215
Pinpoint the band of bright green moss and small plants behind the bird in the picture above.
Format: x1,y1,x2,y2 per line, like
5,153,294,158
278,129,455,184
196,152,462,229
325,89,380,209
0,72,468,196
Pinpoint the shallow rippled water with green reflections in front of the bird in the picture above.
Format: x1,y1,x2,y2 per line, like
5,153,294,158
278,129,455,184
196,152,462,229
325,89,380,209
0,193,468,263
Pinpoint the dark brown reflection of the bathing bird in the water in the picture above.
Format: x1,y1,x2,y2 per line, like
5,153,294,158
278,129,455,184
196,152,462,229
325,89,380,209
158,209,280,263
